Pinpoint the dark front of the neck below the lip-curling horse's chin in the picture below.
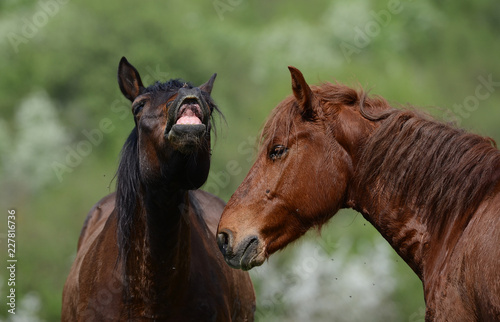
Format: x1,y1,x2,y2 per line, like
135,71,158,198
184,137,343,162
126,189,191,314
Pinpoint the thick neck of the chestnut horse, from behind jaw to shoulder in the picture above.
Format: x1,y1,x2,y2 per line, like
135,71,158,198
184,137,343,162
346,113,500,278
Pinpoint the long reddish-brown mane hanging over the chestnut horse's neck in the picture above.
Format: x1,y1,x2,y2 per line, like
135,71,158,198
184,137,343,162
356,102,500,234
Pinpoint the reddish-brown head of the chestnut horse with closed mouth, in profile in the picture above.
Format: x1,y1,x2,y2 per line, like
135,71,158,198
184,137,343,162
217,67,376,270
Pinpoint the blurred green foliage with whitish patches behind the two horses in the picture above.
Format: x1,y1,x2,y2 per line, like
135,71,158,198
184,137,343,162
0,0,500,321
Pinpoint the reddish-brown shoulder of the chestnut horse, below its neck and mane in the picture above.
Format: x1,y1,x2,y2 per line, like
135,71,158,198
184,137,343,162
425,187,500,321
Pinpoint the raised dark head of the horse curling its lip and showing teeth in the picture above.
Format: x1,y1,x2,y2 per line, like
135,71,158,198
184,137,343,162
118,57,217,189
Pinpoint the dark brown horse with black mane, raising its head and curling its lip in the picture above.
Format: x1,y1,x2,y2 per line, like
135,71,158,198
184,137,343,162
62,58,255,321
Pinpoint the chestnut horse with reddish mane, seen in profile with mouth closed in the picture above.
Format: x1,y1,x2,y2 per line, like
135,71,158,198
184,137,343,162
217,67,500,321
